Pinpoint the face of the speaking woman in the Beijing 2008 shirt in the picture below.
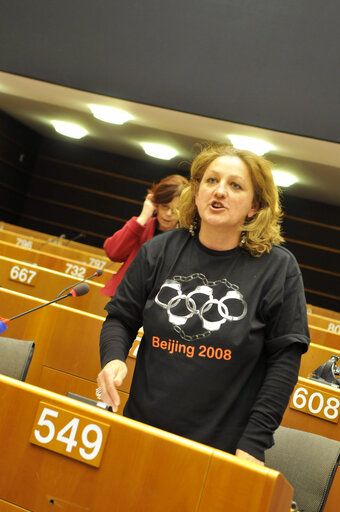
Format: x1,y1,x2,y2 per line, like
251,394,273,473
196,155,258,237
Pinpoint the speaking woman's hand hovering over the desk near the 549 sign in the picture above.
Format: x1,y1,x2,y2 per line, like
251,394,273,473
97,359,127,412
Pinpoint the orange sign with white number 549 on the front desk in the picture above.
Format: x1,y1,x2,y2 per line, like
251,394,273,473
30,402,110,467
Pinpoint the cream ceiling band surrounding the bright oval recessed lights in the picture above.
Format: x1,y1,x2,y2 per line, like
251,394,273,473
0,72,340,206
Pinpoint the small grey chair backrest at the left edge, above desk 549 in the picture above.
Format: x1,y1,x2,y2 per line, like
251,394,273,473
0,336,34,380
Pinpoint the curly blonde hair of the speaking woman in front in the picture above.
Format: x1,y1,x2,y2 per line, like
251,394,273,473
179,144,284,256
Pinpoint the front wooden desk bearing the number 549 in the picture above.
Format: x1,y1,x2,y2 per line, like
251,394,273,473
0,376,293,512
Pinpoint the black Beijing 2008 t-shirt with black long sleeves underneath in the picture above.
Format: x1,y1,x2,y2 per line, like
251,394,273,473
101,229,309,459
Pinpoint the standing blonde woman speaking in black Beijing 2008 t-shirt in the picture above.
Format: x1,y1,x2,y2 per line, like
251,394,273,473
97,145,309,464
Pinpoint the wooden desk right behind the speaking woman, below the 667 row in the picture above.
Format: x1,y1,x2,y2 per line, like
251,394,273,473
0,288,141,413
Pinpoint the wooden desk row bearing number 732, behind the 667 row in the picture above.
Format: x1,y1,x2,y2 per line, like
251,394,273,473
0,239,121,284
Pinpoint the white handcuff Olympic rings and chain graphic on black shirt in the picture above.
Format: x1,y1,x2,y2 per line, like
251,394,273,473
155,273,247,341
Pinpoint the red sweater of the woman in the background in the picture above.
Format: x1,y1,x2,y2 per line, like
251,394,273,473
101,217,157,297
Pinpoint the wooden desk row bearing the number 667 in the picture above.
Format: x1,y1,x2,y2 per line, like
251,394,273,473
0,256,109,318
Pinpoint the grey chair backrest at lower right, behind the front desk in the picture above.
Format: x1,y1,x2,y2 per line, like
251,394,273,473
266,426,340,512
